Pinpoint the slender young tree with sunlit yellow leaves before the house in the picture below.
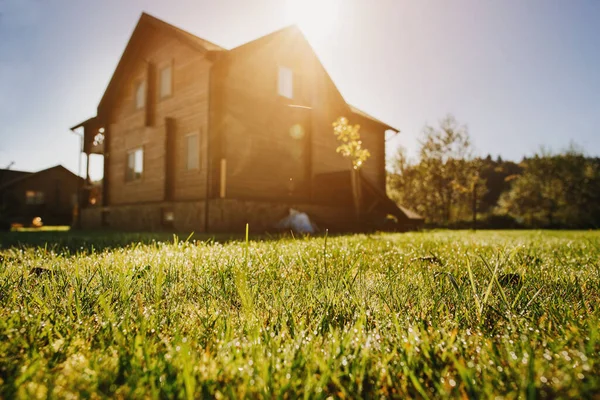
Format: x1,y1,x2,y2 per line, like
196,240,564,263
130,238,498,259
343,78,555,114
333,117,371,219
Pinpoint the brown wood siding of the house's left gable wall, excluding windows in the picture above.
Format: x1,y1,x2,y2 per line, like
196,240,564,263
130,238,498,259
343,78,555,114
101,24,210,204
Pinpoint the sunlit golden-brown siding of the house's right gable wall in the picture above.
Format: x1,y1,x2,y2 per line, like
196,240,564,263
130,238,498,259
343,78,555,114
213,29,356,199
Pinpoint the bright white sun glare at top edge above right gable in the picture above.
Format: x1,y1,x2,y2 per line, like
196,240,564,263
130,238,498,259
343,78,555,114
286,0,343,36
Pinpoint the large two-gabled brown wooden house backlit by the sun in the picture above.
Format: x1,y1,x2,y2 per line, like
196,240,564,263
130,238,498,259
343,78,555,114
72,14,418,232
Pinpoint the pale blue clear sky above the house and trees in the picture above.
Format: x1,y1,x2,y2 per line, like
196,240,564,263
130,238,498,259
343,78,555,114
0,0,600,178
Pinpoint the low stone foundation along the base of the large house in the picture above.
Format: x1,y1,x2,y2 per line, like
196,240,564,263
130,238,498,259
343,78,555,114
81,199,355,233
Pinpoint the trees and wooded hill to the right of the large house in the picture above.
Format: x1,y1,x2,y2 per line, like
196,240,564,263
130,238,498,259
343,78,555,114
387,116,600,229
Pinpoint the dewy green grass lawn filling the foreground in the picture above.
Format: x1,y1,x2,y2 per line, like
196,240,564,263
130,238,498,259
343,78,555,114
0,231,600,398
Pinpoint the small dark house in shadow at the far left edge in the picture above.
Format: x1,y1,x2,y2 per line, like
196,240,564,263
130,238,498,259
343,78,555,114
0,165,83,226
